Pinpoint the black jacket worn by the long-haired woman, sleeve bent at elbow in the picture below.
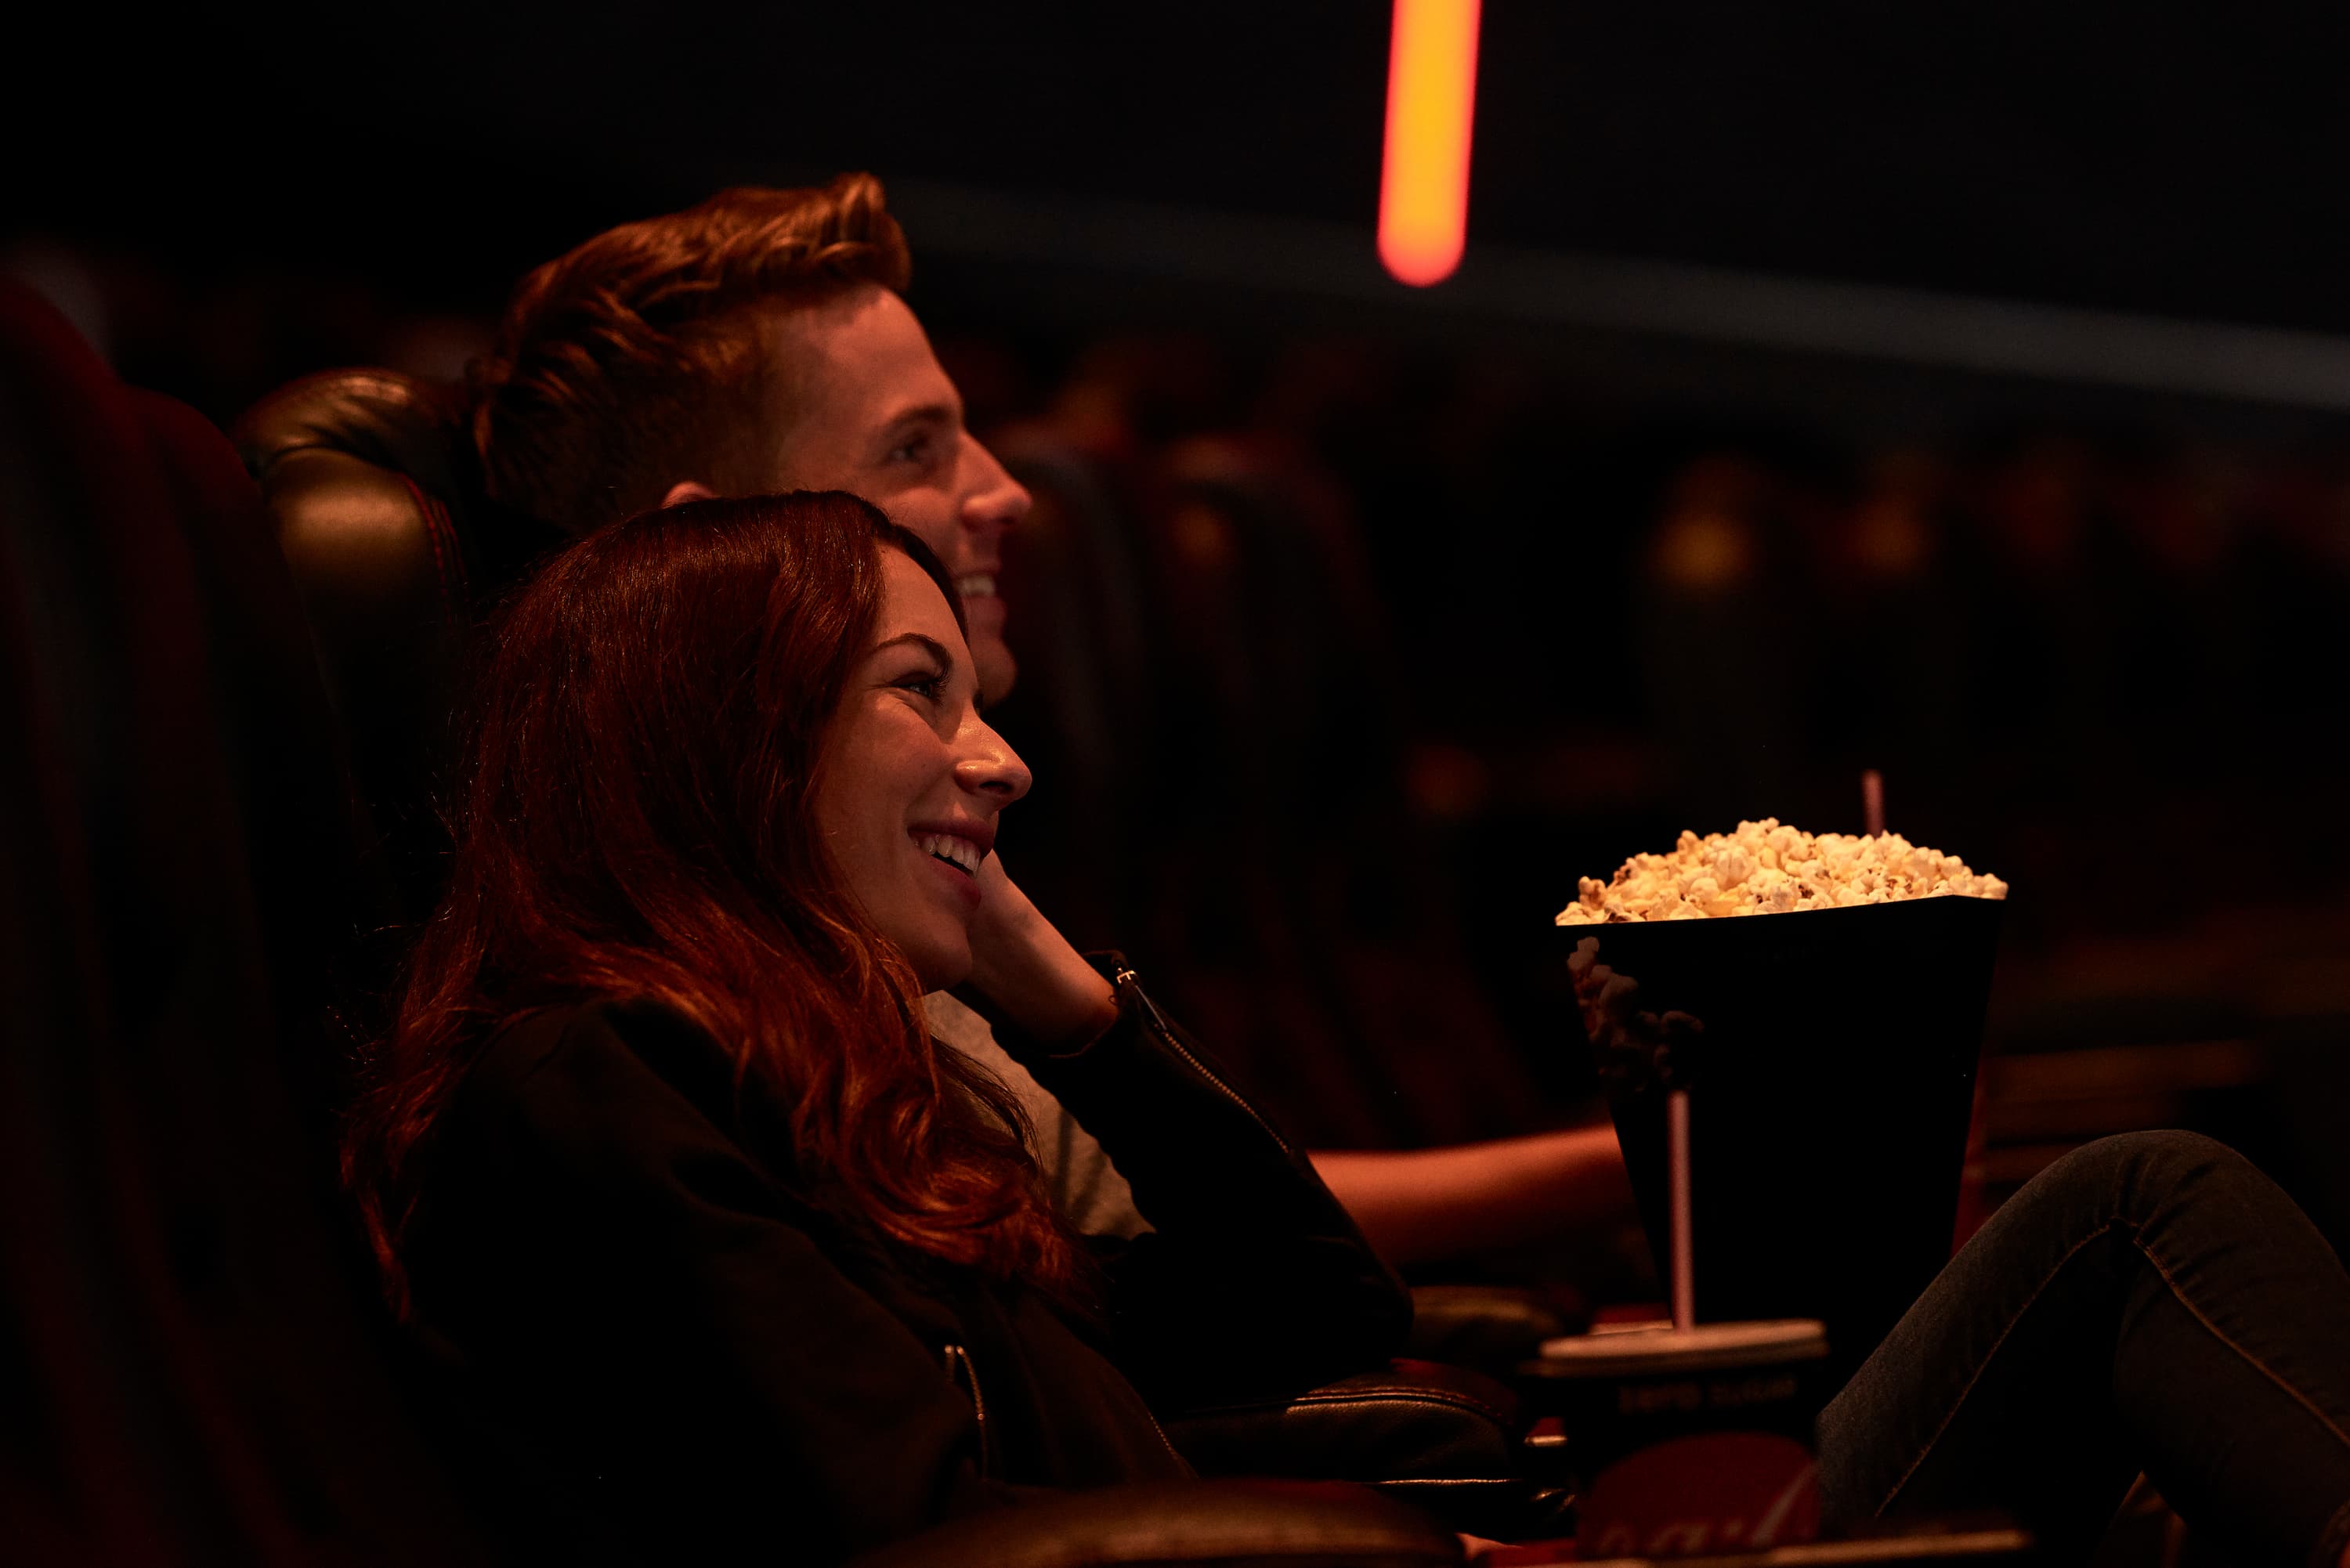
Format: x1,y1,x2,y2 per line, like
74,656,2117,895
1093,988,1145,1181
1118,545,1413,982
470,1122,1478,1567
409,976,1410,1561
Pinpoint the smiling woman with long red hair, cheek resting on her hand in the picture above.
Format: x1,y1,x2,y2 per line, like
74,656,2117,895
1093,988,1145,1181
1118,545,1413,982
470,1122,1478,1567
348,493,1410,1561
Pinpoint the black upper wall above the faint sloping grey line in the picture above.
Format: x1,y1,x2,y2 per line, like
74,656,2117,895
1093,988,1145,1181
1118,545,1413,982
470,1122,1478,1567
12,0,2350,329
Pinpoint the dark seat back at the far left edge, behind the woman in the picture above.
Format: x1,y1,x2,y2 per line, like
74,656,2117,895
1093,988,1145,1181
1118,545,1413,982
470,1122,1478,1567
0,284,482,1563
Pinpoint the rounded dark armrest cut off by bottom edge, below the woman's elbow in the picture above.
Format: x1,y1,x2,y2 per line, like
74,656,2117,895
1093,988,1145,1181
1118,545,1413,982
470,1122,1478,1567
853,1481,1462,1568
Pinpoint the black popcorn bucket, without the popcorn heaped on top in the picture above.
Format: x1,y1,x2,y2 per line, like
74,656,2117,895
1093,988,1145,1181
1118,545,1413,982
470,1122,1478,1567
1558,896,2000,1387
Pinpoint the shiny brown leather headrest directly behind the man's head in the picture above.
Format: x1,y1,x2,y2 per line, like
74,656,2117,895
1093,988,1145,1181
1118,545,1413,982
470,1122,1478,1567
233,369,564,930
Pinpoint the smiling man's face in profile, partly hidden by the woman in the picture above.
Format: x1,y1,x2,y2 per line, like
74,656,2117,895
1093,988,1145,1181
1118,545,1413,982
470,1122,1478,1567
776,284,1029,700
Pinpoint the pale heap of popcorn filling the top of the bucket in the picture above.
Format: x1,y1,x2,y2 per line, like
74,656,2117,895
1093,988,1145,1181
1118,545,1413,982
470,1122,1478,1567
1558,816,2007,927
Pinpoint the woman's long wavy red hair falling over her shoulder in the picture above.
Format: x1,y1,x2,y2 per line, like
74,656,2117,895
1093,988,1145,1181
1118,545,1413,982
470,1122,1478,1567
343,491,1076,1312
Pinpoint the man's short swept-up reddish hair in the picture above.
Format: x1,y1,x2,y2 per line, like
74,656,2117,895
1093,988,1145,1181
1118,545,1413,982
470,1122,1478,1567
470,174,909,533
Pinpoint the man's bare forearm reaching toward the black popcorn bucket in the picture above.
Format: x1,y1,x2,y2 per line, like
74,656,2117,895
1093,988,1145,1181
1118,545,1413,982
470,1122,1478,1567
1311,1122,1633,1265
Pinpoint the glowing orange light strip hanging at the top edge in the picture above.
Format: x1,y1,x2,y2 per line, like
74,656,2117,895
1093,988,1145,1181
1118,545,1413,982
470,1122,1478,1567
1379,0,1478,287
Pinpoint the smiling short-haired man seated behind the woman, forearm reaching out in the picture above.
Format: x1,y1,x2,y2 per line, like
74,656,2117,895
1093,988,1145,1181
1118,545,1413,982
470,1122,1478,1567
472,174,1629,1263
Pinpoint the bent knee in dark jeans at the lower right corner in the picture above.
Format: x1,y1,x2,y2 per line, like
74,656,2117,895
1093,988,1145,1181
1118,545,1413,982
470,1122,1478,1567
1819,1133,2350,1568
